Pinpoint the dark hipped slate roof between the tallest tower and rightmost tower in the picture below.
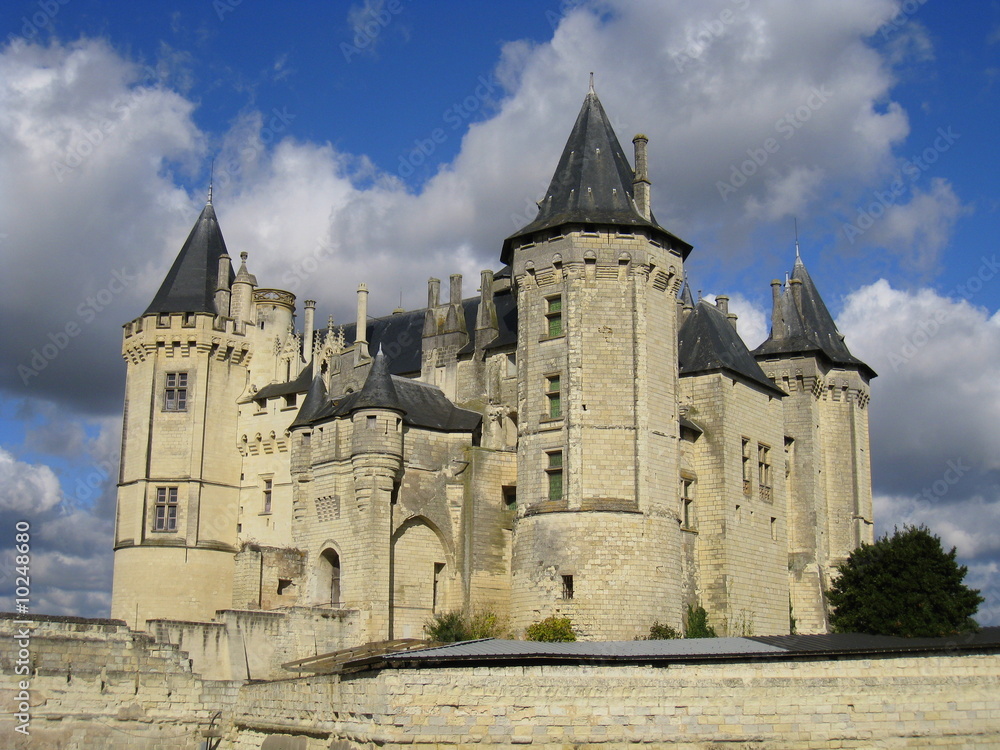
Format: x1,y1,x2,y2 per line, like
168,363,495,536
677,300,785,398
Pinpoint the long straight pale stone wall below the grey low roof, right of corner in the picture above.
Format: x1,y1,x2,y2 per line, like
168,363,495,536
231,654,1000,750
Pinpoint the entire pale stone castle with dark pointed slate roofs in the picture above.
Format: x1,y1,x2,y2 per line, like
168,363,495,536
112,89,875,646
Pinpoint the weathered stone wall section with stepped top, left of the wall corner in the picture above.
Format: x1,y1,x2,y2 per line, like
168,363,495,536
0,617,240,750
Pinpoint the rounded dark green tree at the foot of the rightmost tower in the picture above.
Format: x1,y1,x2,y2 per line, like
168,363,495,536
827,526,984,638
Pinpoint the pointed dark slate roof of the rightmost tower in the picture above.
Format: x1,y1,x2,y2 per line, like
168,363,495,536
753,256,875,378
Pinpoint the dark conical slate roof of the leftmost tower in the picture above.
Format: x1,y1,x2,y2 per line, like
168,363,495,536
143,202,234,315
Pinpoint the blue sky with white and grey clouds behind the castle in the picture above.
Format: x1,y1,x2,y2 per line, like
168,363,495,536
0,0,1000,624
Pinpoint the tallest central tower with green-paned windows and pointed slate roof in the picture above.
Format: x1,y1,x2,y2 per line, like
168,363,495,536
501,83,691,638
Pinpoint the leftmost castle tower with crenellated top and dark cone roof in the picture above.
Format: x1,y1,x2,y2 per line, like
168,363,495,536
111,202,251,629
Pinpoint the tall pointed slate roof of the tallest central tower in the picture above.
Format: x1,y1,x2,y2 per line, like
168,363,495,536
500,89,691,263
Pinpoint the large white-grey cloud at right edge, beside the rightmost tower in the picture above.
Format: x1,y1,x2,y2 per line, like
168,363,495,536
837,280,1000,478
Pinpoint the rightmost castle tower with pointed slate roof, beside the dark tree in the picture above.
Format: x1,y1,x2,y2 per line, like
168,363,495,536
754,253,875,633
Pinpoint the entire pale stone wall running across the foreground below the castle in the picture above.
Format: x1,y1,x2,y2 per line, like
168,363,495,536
0,616,1000,750
